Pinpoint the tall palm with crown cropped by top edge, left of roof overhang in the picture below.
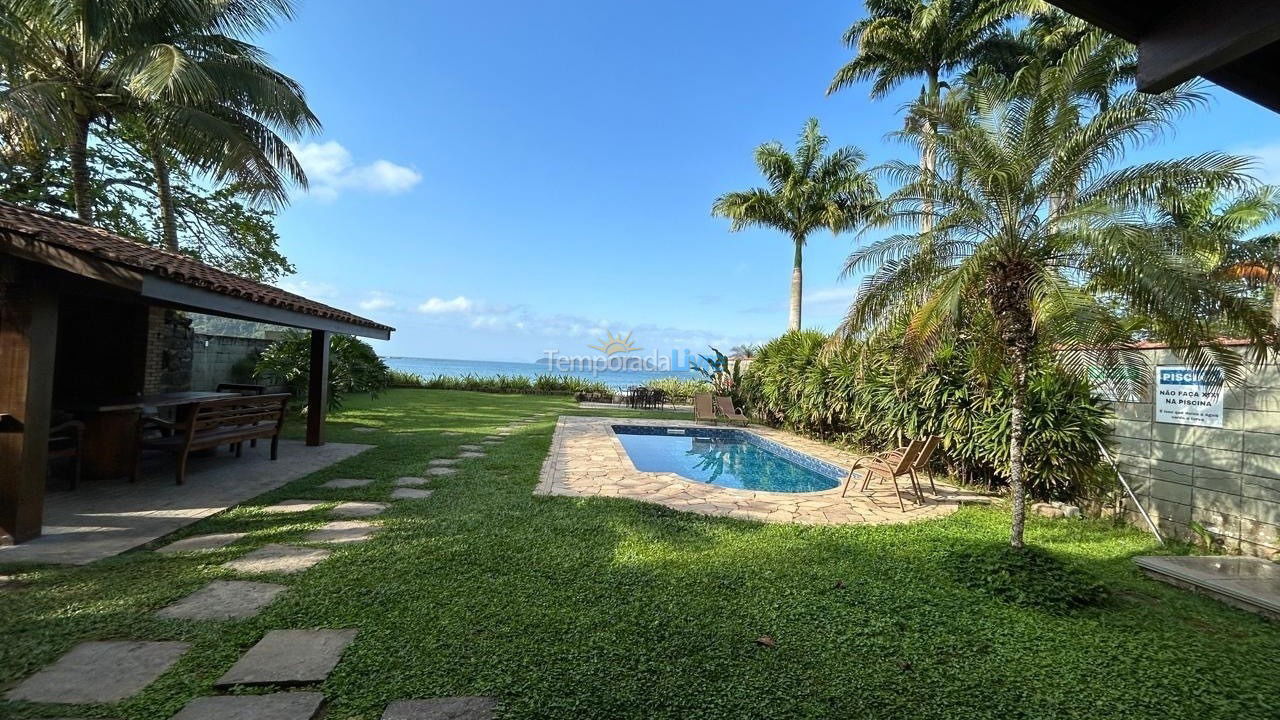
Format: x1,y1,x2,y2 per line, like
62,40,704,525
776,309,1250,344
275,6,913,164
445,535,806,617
827,0,1042,229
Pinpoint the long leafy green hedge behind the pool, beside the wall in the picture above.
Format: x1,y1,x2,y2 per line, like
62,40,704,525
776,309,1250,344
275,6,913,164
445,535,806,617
740,331,1108,498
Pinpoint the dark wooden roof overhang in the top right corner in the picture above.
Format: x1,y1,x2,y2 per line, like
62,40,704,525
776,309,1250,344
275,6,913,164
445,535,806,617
1048,0,1280,111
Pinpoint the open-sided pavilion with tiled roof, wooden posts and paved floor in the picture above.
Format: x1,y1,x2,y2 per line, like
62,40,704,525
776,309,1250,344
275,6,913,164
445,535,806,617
0,202,393,550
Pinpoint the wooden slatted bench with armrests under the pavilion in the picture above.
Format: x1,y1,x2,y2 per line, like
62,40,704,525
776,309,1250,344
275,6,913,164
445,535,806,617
133,393,289,484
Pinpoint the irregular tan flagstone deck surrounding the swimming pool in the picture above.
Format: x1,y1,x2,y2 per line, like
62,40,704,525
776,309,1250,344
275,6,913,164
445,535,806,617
534,416,989,525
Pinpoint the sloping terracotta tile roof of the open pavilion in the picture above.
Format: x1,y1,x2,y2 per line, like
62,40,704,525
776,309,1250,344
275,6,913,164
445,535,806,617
0,201,394,331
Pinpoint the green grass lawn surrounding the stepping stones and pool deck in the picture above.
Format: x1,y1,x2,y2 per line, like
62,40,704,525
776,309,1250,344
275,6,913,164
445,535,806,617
0,389,1280,720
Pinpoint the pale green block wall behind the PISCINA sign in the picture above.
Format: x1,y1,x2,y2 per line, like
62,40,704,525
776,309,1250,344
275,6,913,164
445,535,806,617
1114,350,1280,557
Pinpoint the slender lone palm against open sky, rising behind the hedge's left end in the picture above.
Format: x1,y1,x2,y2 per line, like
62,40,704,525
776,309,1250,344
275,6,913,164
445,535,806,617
712,118,879,331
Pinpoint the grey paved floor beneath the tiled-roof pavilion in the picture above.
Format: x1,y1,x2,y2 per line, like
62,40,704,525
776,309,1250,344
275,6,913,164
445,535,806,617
0,441,372,565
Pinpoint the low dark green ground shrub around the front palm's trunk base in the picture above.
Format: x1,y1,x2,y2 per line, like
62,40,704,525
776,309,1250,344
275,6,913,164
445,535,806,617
946,544,1107,614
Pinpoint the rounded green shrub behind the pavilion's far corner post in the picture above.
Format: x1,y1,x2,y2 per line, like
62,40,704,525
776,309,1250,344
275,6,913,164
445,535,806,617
253,331,390,410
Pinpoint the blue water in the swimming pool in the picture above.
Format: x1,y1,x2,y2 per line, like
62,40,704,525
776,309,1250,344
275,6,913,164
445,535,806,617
613,425,845,492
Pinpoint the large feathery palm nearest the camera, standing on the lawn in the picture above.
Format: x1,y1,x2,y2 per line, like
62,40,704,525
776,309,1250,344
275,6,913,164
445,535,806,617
842,68,1275,547
